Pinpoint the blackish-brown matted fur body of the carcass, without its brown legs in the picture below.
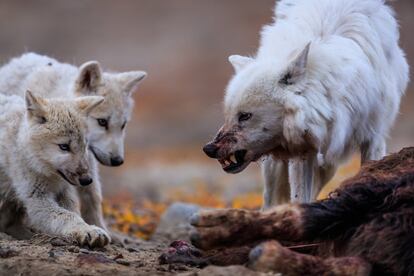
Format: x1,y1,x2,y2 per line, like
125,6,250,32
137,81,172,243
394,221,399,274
303,148,414,275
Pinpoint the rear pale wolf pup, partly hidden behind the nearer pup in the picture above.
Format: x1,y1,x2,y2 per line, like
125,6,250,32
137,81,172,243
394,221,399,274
0,53,146,242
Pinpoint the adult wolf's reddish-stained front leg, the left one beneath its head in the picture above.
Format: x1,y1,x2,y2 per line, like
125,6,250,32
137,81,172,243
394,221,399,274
262,156,290,210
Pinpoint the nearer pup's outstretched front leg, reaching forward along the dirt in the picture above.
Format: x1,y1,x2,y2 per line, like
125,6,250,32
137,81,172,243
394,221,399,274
25,194,110,247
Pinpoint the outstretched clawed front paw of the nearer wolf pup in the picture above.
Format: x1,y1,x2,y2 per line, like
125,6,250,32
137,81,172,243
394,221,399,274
72,225,111,247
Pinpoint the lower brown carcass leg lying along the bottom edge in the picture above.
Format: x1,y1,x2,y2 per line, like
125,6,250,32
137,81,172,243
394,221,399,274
249,241,371,276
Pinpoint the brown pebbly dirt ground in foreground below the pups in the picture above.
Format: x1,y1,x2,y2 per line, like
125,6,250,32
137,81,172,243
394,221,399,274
0,235,271,276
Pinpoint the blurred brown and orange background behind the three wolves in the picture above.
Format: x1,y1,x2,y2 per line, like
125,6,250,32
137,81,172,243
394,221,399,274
0,0,414,230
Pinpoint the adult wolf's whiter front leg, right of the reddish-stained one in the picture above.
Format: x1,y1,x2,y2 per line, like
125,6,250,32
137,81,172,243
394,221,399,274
289,154,318,203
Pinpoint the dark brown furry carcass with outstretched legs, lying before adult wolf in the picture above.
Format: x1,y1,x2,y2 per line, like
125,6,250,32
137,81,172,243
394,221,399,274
192,148,414,276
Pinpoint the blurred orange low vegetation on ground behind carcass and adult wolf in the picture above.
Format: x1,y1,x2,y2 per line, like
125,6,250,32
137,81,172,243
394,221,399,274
104,157,359,239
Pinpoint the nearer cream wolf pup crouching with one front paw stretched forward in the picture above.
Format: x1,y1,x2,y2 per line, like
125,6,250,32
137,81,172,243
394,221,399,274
0,92,110,246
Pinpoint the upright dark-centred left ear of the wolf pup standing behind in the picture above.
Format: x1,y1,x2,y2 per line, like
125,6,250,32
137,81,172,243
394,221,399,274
75,61,102,95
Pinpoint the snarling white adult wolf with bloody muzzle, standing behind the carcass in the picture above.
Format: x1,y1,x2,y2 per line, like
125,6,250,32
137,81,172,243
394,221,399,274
204,0,409,208
